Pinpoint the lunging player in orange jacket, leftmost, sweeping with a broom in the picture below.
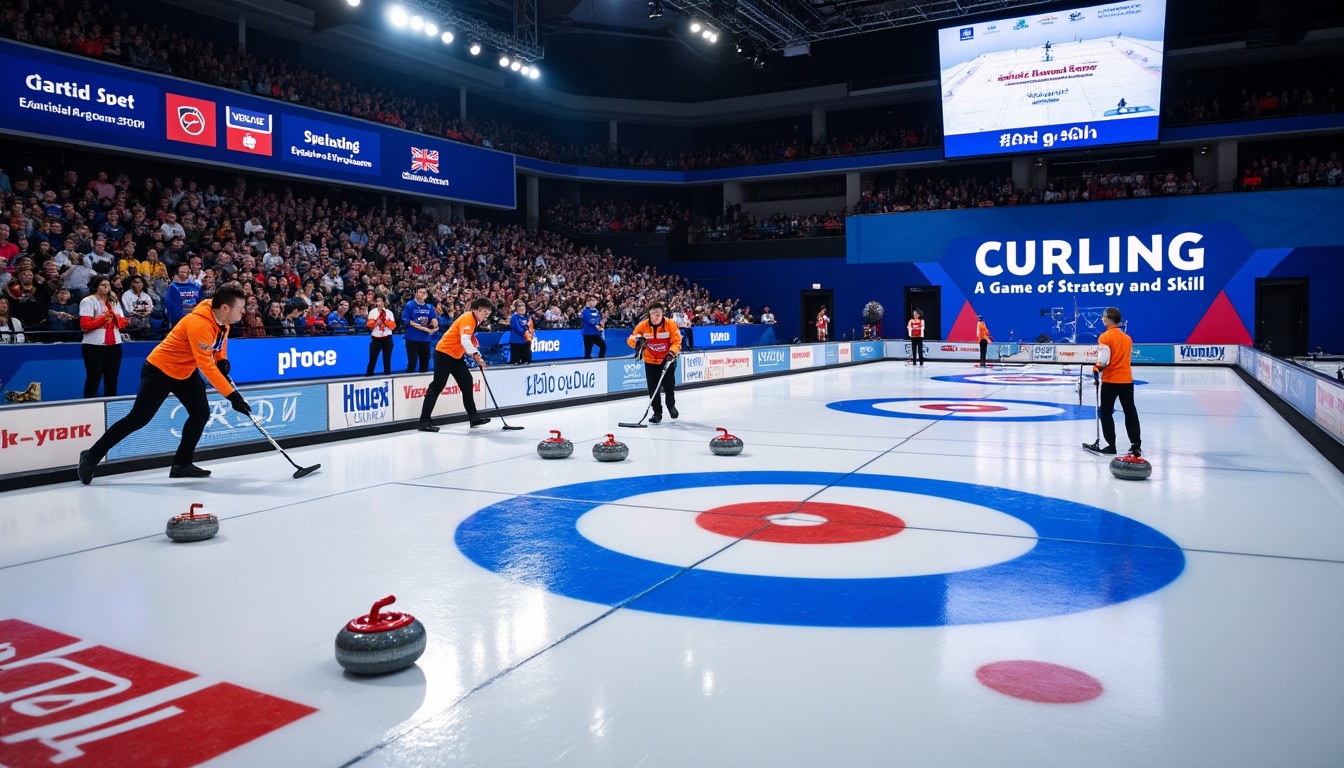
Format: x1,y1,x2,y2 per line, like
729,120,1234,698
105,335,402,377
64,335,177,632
77,282,251,486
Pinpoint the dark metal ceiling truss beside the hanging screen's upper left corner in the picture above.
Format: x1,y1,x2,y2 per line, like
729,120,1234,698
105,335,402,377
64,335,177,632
649,0,1064,55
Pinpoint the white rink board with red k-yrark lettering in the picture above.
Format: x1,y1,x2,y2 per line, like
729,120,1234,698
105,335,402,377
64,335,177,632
0,402,105,473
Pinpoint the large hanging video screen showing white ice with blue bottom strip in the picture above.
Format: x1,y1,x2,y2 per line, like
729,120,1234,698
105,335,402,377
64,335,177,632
938,0,1167,157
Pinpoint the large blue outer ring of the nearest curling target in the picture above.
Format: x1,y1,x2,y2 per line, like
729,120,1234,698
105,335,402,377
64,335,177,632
456,472,1185,627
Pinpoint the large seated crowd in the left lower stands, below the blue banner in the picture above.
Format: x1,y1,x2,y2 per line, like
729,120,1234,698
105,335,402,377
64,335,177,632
0,159,737,342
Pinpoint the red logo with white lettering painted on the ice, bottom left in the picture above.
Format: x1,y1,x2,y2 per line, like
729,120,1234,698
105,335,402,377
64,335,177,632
0,619,317,768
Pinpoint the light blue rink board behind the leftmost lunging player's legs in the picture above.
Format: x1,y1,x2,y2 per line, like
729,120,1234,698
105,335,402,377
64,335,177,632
106,385,328,459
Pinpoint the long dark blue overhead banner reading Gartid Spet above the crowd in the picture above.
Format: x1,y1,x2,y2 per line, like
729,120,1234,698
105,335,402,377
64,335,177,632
0,40,517,208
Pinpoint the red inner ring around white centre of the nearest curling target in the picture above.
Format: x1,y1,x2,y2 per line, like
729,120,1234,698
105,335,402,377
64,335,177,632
695,502,906,543
